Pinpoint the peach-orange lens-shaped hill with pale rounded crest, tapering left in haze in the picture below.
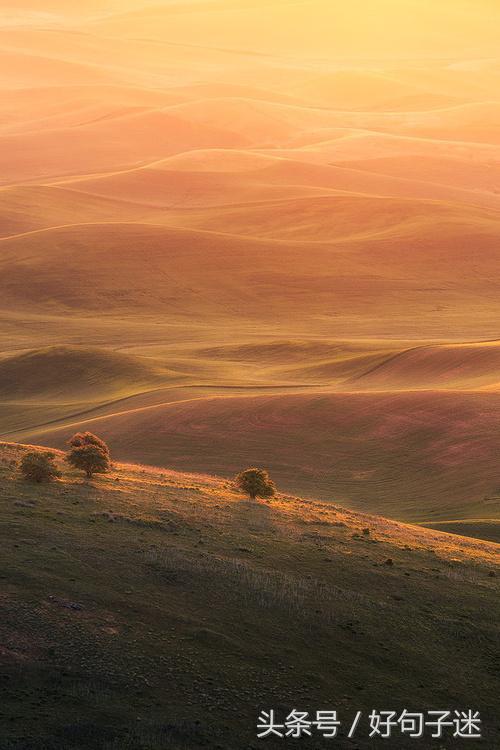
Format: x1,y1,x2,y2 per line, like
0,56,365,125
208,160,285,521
63,149,500,210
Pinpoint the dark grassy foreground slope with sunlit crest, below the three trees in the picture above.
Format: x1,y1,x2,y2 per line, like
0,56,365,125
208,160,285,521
0,444,500,750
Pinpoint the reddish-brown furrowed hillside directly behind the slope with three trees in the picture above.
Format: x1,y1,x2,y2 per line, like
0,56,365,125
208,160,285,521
20,389,500,536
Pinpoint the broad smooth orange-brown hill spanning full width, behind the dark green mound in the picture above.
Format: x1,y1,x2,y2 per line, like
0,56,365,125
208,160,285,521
0,213,499,339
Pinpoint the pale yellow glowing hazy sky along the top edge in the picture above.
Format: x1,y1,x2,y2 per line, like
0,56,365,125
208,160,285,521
0,0,500,58
